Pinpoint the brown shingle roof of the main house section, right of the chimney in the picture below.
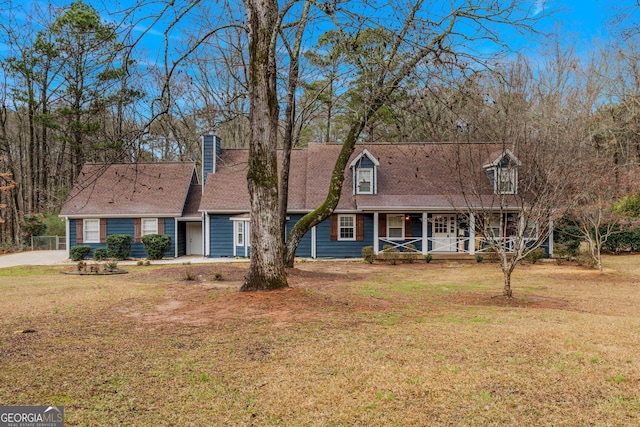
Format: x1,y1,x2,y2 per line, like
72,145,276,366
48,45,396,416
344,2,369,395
200,143,517,212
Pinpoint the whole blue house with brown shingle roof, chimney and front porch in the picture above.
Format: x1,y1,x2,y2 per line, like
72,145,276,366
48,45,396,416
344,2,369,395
61,135,553,258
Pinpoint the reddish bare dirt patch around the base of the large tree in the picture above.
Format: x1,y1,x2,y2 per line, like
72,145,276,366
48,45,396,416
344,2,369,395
119,265,388,327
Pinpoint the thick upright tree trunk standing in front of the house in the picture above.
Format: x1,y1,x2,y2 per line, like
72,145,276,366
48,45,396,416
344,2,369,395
240,0,288,291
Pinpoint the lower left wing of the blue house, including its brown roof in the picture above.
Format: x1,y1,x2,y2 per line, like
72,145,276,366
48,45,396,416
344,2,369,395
60,162,203,258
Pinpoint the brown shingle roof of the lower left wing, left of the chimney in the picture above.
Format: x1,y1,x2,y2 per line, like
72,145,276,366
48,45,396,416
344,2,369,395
60,163,195,216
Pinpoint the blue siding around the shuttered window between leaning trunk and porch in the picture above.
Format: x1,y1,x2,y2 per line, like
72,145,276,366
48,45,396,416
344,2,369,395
316,214,373,258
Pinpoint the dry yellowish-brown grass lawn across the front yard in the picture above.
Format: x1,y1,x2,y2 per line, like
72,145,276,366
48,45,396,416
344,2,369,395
0,256,640,426
